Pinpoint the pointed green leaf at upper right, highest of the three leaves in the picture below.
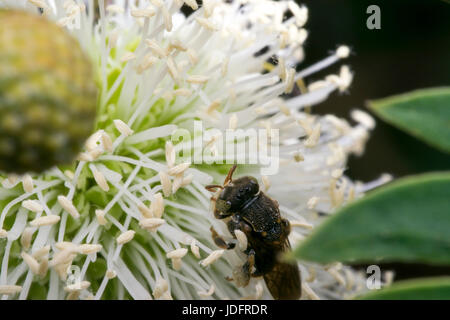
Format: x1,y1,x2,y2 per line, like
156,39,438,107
368,87,450,152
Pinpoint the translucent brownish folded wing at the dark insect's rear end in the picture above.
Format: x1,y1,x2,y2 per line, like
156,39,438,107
264,240,302,300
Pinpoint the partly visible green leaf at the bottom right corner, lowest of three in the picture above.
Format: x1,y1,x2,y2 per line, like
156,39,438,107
357,277,450,300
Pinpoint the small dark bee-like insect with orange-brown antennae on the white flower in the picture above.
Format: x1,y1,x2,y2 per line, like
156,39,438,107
206,165,301,300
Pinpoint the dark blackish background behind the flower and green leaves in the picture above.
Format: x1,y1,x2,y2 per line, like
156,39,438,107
299,0,450,280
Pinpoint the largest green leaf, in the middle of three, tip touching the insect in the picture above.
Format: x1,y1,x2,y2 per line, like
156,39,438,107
293,172,450,265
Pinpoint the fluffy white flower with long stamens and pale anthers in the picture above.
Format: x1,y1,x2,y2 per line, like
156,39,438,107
0,0,390,299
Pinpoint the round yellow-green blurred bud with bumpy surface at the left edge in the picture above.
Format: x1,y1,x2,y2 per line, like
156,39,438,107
0,10,97,174
